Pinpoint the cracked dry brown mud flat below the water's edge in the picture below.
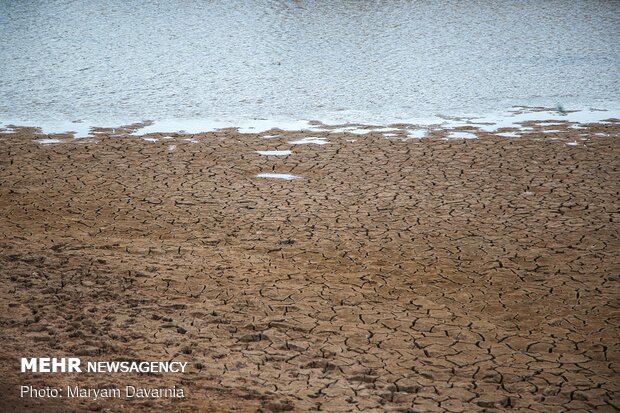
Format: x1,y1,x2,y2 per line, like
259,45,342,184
0,123,620,412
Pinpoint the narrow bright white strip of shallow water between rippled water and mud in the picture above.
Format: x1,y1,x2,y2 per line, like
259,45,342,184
0,106,620,138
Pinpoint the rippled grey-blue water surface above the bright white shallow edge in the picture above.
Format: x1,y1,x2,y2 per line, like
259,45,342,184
0,0,620,130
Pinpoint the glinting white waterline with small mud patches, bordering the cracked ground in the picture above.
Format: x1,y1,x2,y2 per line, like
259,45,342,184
0,104,620,138
